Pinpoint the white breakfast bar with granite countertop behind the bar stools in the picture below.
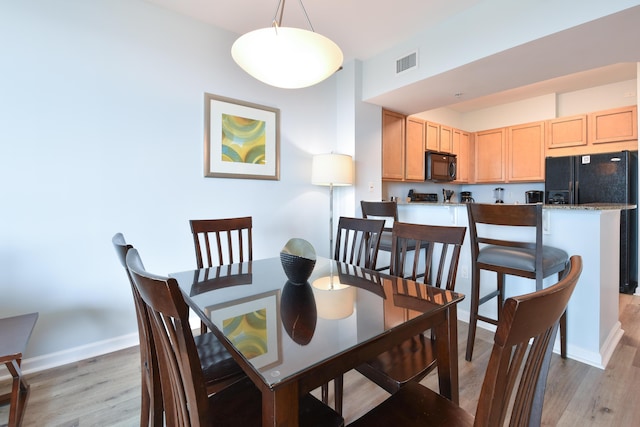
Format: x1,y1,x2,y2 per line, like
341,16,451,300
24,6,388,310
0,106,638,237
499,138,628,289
392,202,636,369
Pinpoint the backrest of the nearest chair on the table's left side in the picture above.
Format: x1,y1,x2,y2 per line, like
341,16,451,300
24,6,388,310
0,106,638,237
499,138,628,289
126,249,208,426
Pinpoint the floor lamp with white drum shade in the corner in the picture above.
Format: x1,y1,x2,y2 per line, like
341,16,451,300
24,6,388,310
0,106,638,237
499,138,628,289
311,153,353,259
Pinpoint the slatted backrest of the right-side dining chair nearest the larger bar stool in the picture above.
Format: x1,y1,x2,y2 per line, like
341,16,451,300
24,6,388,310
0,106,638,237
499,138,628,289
389,221,467,291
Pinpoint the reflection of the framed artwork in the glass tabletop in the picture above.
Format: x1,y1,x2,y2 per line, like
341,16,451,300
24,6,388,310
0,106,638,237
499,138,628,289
205,289,282,369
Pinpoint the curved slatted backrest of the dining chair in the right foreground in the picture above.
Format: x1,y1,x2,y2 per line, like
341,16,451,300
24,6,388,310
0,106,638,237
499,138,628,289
474,255,582,426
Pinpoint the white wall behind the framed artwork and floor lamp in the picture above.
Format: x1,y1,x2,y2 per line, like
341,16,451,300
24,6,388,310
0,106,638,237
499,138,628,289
0,0,353,366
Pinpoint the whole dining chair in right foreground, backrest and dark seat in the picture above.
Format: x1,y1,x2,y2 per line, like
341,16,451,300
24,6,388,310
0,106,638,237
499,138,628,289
349,256,582,427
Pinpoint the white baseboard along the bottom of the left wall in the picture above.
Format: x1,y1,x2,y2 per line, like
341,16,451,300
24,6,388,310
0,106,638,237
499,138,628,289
0,333,139,380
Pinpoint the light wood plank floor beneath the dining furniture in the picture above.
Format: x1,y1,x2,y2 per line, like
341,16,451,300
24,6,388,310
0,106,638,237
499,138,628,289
0,295,640,427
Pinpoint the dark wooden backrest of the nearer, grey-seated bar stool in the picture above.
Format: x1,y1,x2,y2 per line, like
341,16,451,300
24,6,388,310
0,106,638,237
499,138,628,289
467,203,543,280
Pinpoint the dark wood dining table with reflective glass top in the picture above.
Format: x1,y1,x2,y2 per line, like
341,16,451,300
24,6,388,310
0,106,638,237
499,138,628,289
170,258,464,426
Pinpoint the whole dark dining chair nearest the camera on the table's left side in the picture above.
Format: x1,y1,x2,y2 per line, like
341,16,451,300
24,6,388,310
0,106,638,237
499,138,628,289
126,249,344,427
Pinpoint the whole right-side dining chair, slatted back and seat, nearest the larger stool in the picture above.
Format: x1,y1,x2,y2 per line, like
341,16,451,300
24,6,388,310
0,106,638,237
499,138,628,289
356,222,467,394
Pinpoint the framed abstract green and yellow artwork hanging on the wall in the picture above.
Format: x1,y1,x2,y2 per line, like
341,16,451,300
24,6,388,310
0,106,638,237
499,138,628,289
204,93,280,180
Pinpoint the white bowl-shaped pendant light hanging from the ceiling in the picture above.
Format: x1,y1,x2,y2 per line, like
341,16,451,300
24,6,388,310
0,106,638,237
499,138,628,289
231,0,343,89
